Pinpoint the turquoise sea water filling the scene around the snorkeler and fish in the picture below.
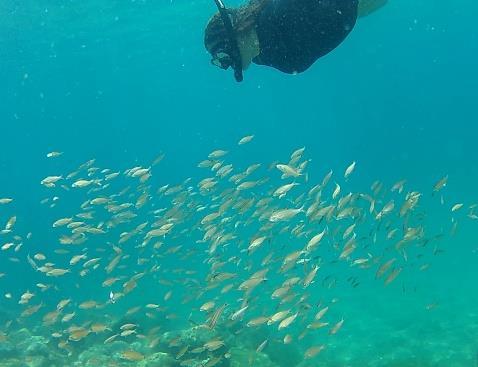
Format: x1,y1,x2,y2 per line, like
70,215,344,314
0,0,478,367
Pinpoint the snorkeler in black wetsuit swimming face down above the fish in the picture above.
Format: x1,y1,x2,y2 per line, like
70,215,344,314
204,0,387,82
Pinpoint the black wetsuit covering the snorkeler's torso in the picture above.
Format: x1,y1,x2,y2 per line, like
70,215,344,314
253,0,358,73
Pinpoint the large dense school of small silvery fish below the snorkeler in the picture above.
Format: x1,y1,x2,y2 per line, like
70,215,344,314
0,139,472,367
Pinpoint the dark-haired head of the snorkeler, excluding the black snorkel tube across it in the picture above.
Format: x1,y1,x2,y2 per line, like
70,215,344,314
204,0,268,78
